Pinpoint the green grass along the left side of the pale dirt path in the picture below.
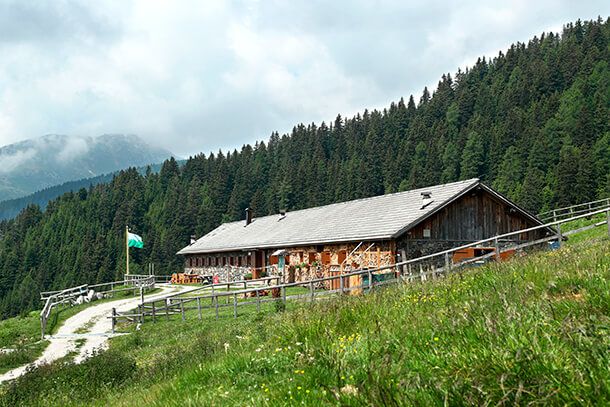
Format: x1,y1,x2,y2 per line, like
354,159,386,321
0,289,158,374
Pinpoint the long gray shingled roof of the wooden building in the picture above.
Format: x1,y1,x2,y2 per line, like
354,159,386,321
178,178,508,254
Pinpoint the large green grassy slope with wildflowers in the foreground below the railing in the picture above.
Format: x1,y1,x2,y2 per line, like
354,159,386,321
0,235,610,406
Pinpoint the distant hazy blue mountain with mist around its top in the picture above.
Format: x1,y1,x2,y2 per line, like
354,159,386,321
0,134,172,201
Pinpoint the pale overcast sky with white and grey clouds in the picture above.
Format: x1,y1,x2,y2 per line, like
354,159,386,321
0,0,610,156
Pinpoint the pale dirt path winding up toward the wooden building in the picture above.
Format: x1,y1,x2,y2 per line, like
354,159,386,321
0,284,193,383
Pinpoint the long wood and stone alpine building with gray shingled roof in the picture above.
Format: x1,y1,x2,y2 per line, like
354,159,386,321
178,178,550,281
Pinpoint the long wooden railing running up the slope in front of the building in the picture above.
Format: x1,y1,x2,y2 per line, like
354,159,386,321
109,206,610,332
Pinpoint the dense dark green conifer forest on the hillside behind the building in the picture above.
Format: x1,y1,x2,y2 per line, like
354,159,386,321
0,18,610,317
